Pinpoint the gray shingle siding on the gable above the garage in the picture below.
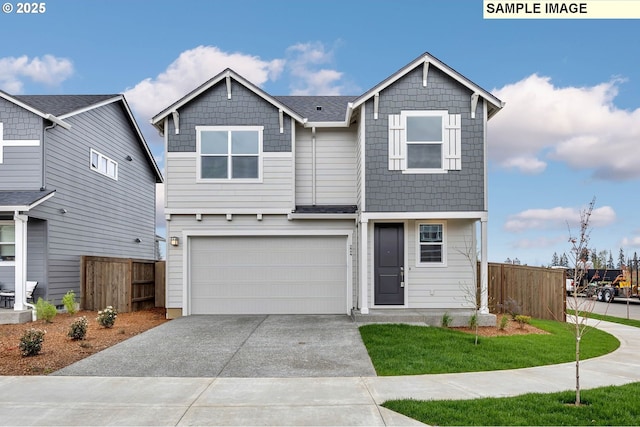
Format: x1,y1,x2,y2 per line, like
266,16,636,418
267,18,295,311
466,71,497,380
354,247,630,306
167,81,291,152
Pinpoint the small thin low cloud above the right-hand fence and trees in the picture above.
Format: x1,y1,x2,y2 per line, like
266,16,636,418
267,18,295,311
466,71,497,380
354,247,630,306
504,206,616,233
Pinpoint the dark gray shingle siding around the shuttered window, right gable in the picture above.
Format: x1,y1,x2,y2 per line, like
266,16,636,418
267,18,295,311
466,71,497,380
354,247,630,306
365,67,484,212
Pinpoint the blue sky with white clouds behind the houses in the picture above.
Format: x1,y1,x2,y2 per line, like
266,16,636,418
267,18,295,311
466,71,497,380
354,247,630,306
0,0,640,265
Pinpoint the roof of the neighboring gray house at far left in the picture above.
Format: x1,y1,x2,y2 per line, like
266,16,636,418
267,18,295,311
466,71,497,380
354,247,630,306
0,91,163,183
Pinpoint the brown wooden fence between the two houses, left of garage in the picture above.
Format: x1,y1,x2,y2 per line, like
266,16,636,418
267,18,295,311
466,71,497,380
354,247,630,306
80,256,165,313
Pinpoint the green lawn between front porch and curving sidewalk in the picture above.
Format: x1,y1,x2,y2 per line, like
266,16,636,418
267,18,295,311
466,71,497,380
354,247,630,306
360,319,620,376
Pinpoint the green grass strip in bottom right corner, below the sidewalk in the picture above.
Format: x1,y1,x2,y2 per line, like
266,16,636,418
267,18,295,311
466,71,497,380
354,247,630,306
382,383,640,426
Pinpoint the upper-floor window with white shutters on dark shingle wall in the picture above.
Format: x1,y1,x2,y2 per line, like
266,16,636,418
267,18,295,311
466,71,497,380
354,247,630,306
389,110,461,173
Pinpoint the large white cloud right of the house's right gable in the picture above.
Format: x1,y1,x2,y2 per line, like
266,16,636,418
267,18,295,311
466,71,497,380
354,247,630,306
489,74,640,180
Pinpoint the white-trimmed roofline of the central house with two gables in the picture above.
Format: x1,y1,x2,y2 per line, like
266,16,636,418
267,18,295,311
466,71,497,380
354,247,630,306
151,52,504,132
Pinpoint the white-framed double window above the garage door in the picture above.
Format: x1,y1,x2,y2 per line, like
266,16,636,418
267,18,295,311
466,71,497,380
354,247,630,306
196,126,263,181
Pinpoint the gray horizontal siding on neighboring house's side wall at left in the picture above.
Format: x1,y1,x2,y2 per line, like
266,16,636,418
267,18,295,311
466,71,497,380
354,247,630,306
30,104,155,301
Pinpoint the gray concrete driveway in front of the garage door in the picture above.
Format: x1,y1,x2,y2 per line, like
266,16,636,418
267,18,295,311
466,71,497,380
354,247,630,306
52,315,376,378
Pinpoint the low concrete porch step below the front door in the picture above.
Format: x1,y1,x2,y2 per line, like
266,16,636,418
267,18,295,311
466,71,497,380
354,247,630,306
351,309,496,327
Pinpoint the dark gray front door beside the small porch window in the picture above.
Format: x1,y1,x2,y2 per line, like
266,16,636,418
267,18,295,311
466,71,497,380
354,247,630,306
373,223,404,305
